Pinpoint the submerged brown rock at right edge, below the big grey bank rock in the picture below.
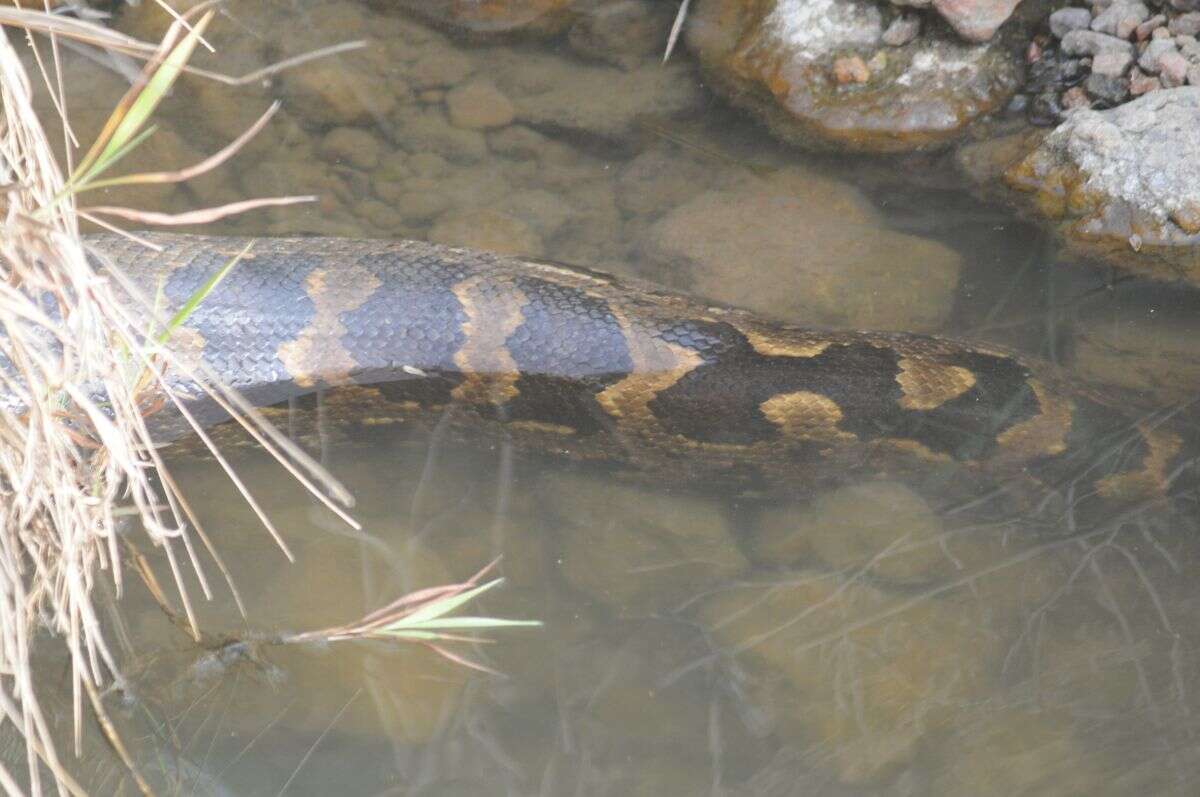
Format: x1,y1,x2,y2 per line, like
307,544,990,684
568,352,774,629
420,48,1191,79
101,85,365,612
1072,286,1200,406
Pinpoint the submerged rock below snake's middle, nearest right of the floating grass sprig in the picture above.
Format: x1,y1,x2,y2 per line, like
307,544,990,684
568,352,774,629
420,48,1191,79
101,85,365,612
541,474,748,617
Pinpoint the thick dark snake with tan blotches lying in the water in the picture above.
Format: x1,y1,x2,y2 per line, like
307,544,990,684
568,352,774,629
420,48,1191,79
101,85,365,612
88,234,1187,513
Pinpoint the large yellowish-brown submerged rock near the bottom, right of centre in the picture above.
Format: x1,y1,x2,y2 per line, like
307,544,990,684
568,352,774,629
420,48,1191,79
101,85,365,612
696,570,997,793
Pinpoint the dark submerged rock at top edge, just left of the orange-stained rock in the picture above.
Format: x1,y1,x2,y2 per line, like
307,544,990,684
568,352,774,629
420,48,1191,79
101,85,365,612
568,0,674,70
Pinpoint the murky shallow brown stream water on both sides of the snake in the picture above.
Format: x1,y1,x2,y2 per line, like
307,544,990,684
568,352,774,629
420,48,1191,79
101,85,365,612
11,2,1200,797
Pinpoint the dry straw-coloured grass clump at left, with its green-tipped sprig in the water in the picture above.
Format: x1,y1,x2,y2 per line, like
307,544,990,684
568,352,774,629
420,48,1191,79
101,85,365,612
0,4,540,793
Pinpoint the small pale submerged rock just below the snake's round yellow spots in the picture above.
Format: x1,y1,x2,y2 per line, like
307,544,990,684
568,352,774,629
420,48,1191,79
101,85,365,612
751,481,955,585
